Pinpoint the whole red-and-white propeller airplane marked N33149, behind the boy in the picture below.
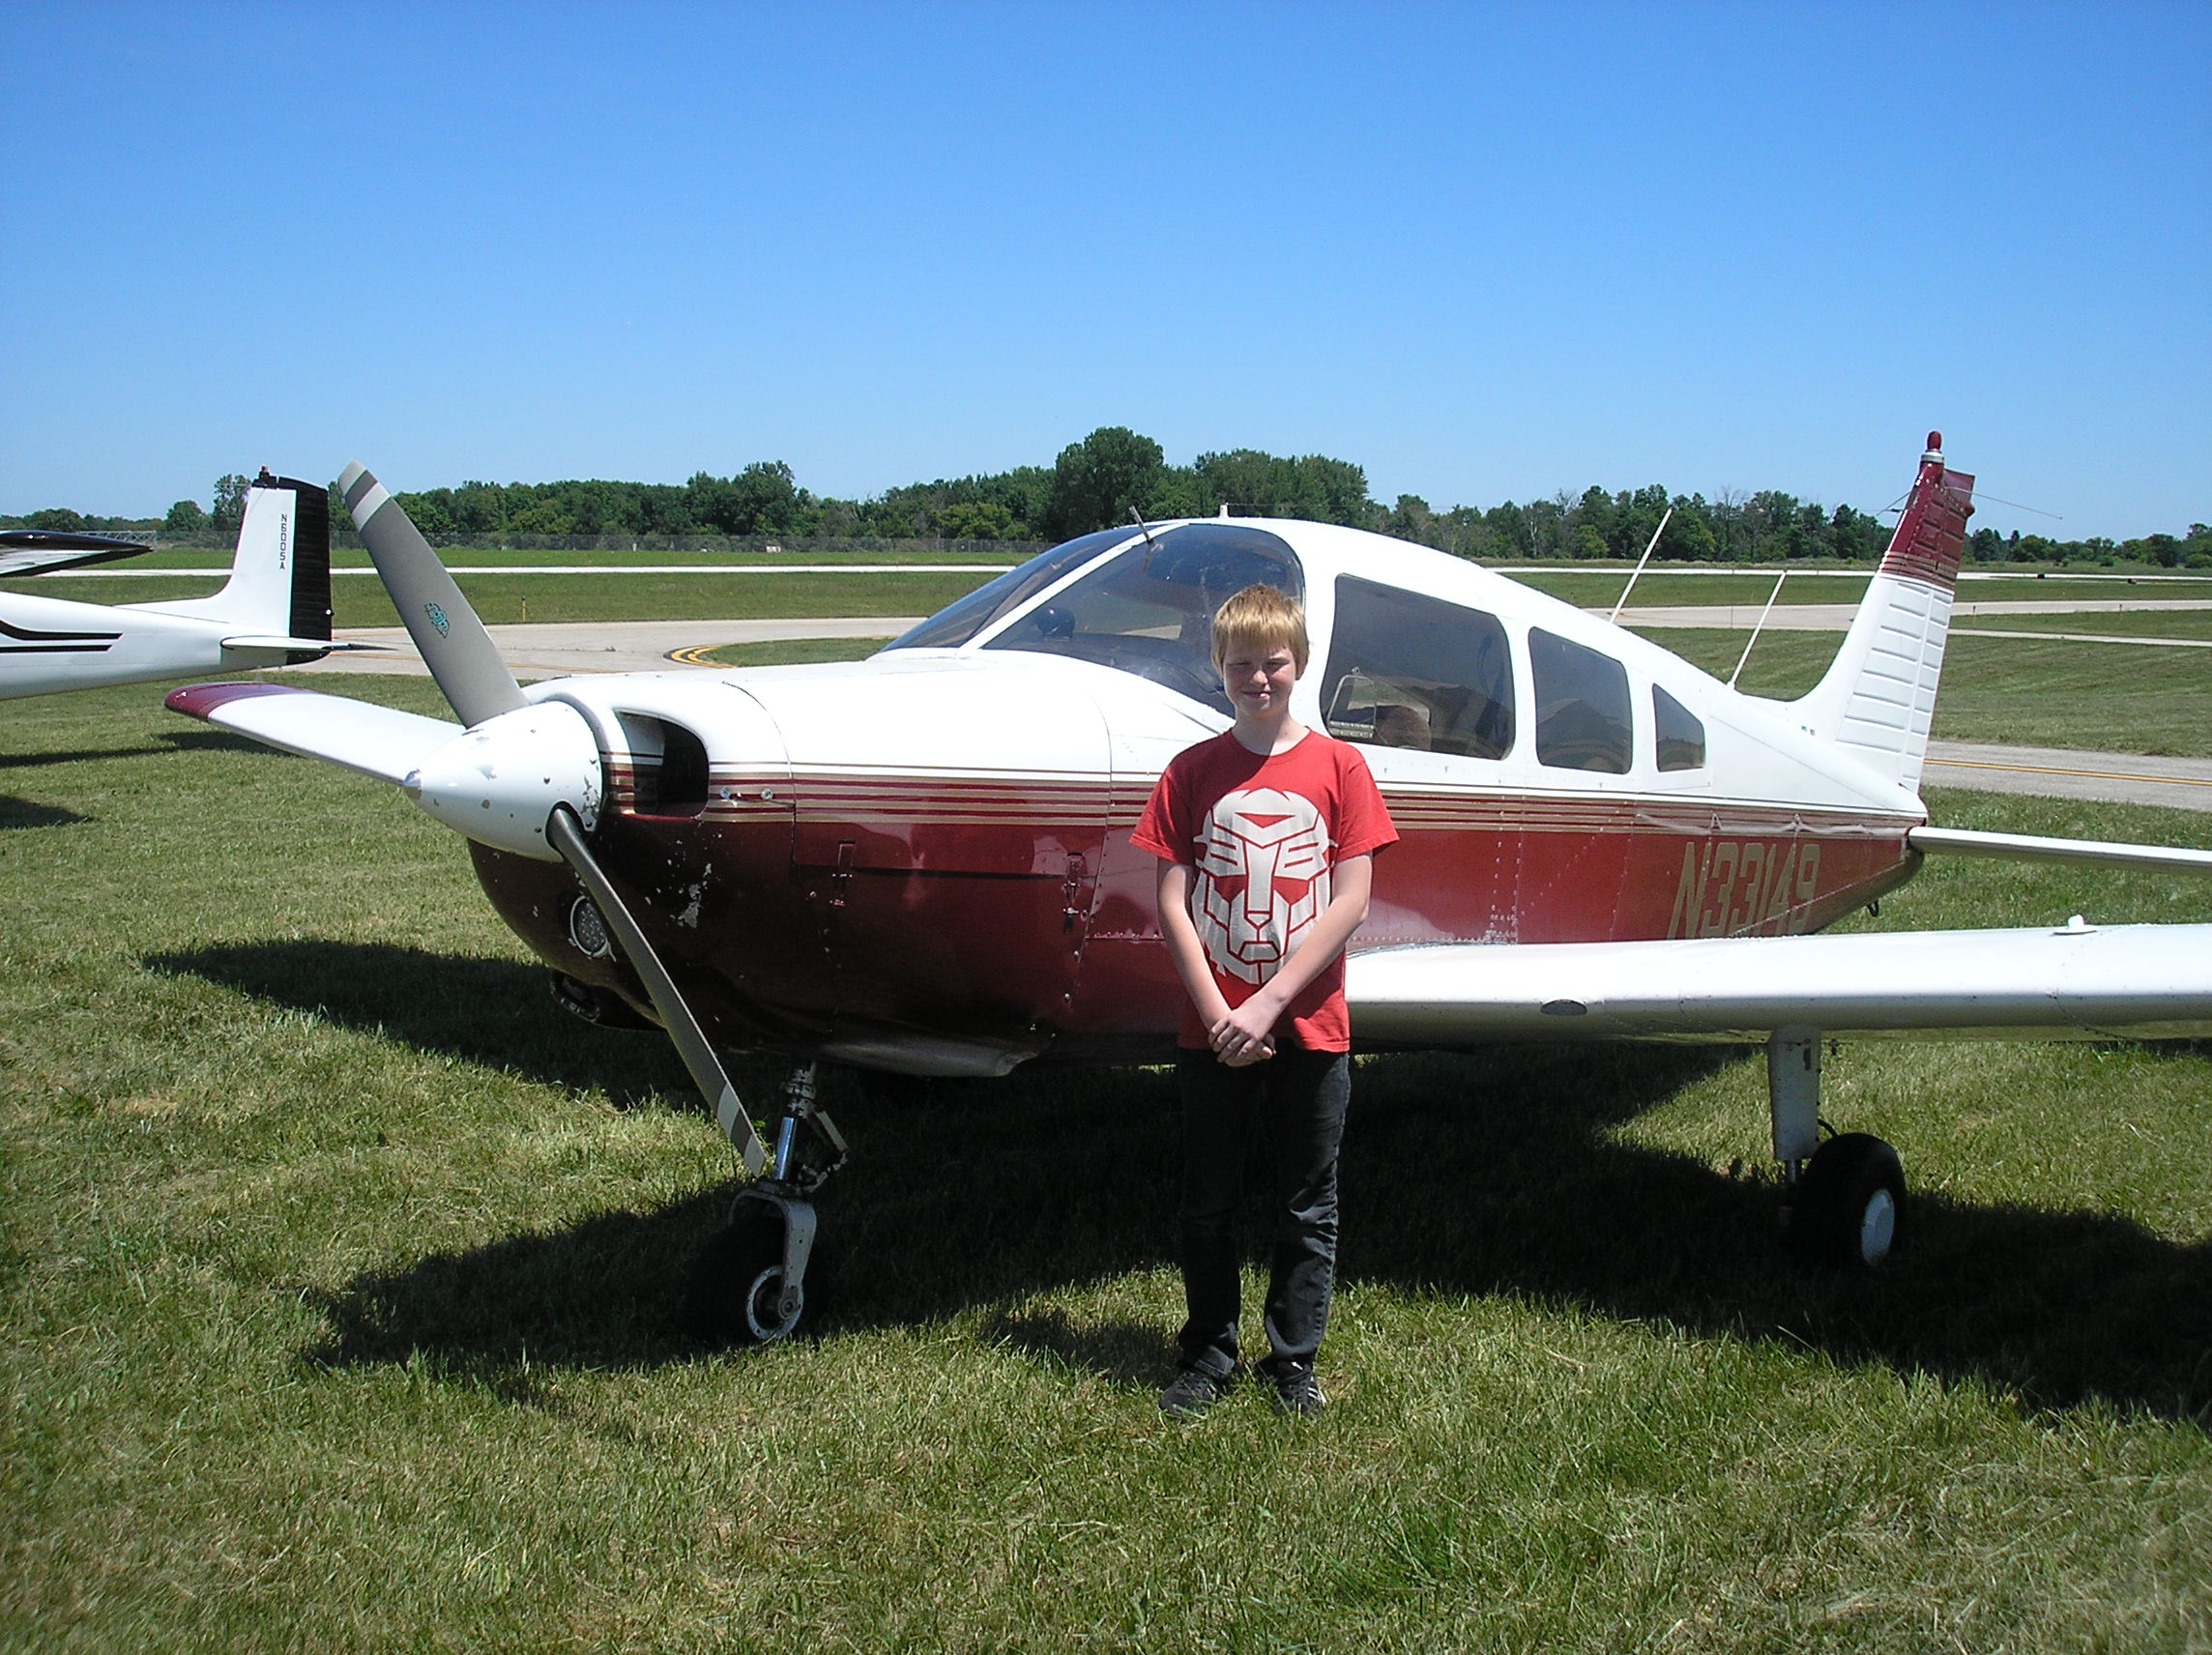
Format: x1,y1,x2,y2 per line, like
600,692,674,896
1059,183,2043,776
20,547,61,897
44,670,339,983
168,434,2212,1341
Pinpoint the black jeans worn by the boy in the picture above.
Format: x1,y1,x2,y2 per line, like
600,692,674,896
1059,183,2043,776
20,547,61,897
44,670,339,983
1175,1047,1352,1379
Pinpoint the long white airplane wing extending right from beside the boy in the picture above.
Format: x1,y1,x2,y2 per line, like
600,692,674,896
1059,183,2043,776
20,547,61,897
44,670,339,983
1345,920,2212,1047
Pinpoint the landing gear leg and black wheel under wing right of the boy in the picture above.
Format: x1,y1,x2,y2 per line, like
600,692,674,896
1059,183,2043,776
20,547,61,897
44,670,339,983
1767,1027,1905,1267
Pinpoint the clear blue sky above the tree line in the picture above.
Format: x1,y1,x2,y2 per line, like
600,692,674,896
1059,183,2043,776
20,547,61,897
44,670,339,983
0,0,2212,537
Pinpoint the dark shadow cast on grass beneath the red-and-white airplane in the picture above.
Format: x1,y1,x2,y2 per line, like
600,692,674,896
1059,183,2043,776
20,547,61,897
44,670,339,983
148,943,2212,1418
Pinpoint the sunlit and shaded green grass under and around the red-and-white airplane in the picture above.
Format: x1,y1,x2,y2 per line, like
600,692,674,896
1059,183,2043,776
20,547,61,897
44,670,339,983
0,680,2212,1650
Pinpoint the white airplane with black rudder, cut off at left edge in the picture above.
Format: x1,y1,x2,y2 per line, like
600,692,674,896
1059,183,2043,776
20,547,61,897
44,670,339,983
0,472,350,699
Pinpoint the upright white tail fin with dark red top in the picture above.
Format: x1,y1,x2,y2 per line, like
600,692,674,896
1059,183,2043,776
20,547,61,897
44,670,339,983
1791,431,1973,792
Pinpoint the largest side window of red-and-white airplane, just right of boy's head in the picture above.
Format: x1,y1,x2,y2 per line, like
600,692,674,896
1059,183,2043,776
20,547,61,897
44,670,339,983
1321,575,1513,759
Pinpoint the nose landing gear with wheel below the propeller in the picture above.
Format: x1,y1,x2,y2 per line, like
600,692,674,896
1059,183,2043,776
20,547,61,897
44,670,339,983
690,1064,847,1346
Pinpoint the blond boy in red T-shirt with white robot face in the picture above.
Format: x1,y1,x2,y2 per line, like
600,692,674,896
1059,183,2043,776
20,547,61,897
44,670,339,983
1130,587,1398,1418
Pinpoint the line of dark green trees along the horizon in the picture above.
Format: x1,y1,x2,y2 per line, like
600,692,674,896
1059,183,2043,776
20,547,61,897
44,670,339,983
0,424,2212,568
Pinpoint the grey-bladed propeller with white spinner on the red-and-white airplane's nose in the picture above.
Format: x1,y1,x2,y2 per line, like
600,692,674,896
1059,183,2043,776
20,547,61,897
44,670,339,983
338,460,768,1177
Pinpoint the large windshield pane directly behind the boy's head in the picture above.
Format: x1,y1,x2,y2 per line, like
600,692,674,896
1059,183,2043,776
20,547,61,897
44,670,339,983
981,522,1305,712
